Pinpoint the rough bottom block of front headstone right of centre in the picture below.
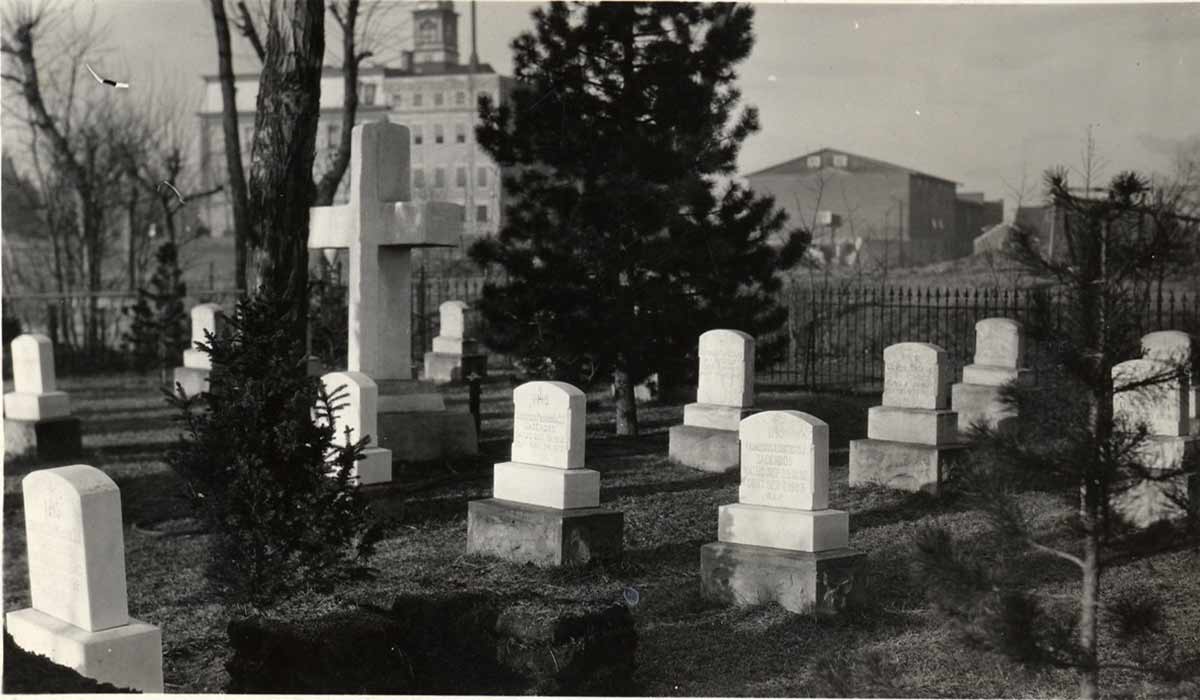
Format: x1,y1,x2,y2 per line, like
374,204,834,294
700,542,863,612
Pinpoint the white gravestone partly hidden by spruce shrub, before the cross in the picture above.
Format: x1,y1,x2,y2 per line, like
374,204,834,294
320,372,391,486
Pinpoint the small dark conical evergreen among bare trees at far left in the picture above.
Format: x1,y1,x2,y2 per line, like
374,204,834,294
122,241,191,383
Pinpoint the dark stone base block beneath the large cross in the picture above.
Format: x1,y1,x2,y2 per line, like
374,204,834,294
378,409,479,462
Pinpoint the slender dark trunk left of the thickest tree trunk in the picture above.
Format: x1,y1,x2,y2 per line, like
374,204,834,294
211,0,250,292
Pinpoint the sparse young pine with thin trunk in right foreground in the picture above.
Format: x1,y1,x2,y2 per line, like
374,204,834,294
916,170,1200,698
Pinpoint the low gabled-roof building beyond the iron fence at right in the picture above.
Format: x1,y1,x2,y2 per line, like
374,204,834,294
745,148,1003,265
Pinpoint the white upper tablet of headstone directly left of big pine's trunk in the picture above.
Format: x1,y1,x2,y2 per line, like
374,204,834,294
512,382,587,469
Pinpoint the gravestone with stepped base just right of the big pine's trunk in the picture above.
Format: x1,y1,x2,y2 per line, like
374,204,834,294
668,329,755,472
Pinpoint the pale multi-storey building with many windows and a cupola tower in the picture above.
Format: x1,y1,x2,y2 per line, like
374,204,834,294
199,0,512,256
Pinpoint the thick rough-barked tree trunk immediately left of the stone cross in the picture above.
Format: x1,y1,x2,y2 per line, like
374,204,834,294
250,0,325,337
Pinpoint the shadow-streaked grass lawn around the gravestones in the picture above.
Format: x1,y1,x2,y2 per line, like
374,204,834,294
4,376,1200,698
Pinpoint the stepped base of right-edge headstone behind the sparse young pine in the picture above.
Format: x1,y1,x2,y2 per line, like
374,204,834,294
1112,436,1200,527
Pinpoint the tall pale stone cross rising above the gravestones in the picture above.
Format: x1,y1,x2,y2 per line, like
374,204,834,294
308,121,463,381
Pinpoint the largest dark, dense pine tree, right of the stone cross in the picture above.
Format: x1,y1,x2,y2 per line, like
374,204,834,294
470,2,808,435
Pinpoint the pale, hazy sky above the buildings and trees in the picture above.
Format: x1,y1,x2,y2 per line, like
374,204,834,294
6,0,1200,218
